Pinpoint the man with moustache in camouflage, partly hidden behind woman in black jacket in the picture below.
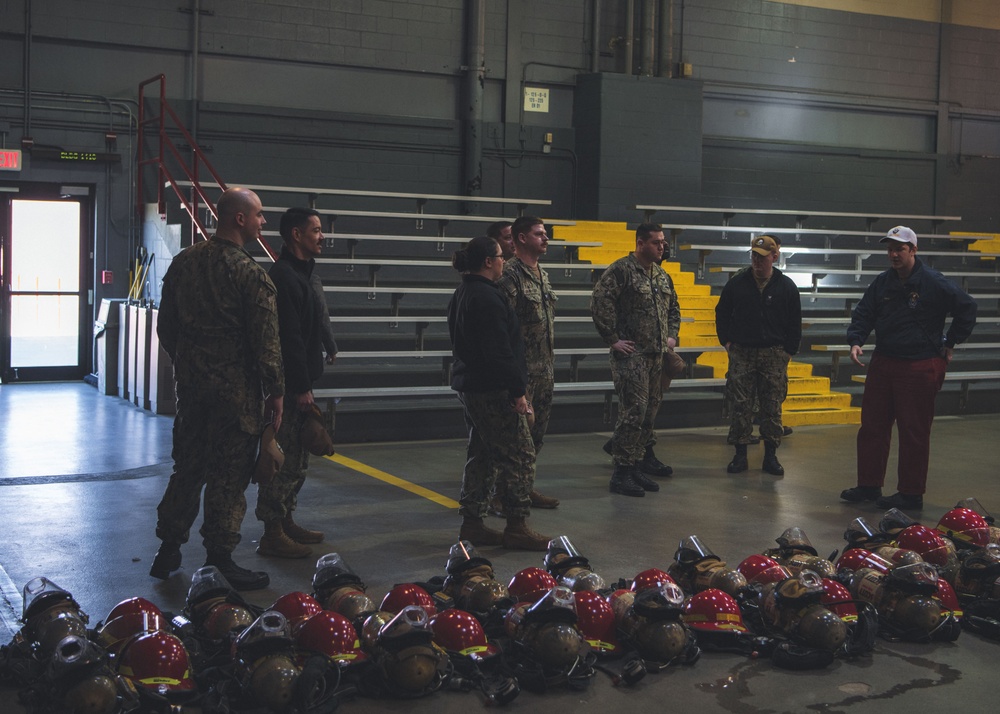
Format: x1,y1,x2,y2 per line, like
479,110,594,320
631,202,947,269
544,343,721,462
491,216,559,514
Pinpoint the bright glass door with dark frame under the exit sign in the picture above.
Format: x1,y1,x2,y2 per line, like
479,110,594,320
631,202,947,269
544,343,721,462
0,198,87,382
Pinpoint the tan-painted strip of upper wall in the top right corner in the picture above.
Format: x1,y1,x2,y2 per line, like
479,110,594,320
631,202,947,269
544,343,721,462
771,0,1000,30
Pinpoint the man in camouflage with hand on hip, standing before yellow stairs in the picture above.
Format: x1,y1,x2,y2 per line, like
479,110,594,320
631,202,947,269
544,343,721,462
591,223,681,496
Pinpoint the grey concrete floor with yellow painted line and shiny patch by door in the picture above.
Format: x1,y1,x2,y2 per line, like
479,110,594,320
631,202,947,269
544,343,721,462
0,384,1000,714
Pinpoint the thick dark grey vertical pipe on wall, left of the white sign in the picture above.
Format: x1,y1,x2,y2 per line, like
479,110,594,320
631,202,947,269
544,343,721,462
463,0,486,204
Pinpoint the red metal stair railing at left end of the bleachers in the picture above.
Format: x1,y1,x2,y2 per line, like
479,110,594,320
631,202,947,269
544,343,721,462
136,74,277,260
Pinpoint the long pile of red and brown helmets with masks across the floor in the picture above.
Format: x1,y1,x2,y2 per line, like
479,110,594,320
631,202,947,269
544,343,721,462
0,499,1000,714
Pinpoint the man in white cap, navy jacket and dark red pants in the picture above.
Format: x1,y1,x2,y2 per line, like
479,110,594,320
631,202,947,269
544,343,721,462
840,226,976,510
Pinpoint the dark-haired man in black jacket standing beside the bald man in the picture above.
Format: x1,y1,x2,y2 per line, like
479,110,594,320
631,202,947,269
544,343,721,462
256,208,323,558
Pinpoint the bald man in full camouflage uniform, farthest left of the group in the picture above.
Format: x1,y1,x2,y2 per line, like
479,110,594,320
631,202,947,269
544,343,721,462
149,188,285,590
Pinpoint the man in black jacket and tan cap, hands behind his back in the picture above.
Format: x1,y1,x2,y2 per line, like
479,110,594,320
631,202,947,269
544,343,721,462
715,235,802,476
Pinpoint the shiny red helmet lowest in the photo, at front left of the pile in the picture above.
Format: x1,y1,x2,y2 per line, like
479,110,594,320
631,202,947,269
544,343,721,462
118,631,197,696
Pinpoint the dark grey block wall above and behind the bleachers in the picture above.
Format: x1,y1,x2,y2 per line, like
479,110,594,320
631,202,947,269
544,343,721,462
0,0,1000,322
